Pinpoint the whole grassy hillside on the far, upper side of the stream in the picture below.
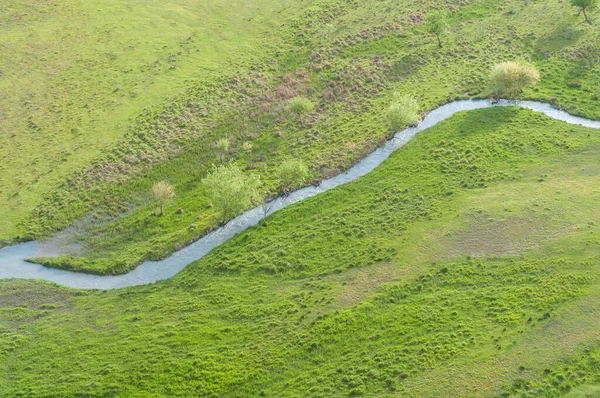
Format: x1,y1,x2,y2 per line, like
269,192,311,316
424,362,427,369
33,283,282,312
0,0,600,273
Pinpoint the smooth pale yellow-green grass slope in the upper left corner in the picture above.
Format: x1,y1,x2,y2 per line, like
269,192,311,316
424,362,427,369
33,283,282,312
0,0,390,243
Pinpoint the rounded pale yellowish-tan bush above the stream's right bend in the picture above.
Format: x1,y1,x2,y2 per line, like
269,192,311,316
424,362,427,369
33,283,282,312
490,61,540,98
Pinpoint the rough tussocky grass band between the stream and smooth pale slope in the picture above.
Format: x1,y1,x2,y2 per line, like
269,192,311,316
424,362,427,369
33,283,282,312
8,0,600,274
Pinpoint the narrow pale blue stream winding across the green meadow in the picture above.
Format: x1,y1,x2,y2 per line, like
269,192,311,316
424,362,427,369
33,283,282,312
0,100,600,289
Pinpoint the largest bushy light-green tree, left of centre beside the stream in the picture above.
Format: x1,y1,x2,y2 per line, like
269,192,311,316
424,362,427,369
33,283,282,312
202,163,260,221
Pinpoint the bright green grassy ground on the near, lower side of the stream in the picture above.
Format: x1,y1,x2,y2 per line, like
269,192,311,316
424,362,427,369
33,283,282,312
0,108,600,397
